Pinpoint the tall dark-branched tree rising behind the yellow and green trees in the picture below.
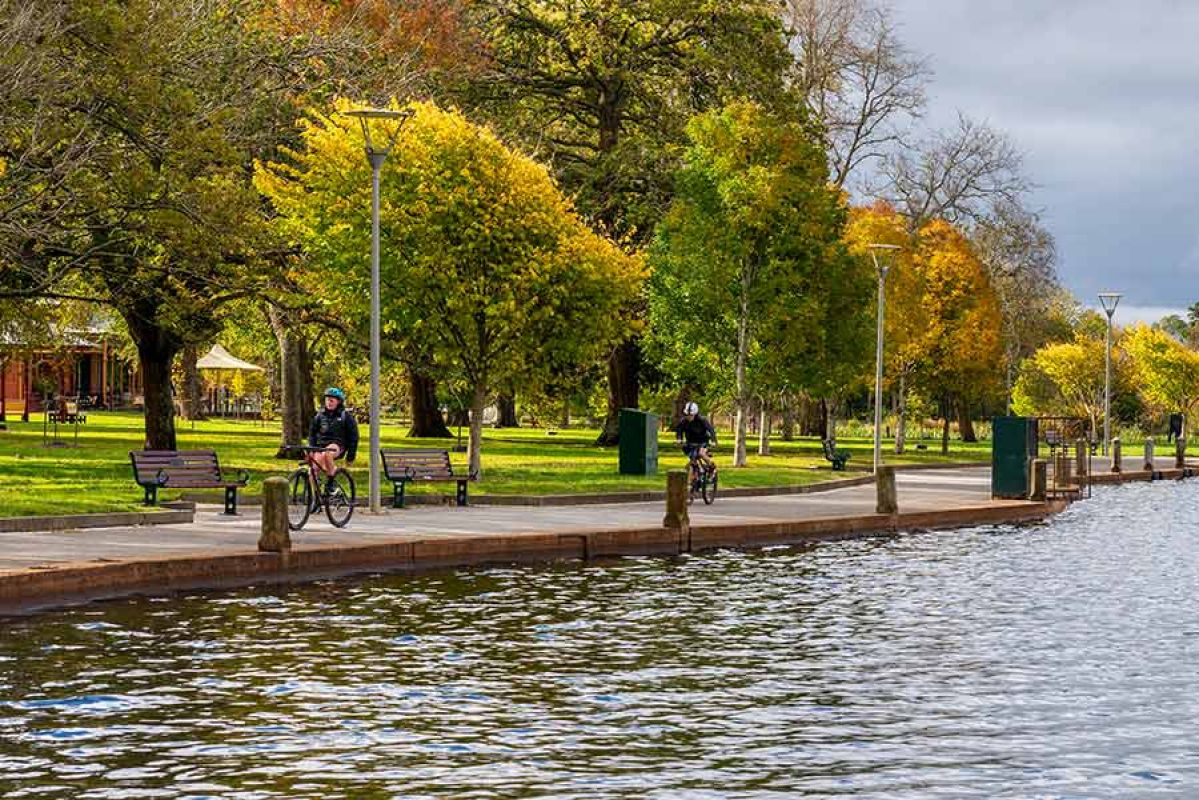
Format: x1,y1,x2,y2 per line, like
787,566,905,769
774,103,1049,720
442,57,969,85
466,0,790,444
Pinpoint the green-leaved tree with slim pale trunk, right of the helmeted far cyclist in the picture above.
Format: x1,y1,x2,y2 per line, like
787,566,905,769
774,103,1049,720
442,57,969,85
650,102,869,467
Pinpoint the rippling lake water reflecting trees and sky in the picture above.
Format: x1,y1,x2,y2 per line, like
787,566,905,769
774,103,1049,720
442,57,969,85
0,483,1199,800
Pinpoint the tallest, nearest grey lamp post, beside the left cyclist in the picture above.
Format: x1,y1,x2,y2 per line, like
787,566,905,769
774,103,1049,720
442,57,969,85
347,108,410,513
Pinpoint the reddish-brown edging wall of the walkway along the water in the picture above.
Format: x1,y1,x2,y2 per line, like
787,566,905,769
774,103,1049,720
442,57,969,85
0,500,1066,614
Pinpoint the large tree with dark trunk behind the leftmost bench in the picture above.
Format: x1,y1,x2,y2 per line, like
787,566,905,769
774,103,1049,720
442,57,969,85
4,0,287,449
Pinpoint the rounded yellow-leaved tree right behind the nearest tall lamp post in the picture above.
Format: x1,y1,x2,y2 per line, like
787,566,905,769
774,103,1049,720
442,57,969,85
258,103,643,473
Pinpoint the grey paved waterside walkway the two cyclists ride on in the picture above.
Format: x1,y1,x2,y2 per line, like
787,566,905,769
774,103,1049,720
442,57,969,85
0,468,992,572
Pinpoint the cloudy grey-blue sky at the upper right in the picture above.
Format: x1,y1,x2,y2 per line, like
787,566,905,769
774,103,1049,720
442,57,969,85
891,0,1199,324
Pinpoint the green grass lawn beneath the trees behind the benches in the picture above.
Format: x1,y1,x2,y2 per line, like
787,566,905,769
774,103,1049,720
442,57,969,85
0,411,990,517
